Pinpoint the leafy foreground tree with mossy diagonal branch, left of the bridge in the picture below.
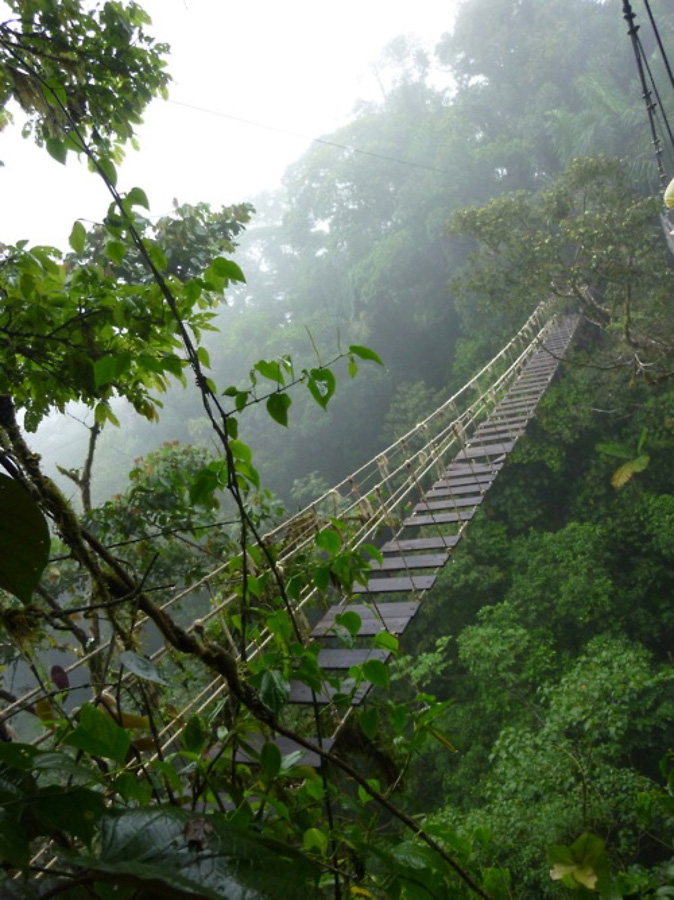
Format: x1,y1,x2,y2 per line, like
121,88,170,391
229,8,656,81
0,0,494,898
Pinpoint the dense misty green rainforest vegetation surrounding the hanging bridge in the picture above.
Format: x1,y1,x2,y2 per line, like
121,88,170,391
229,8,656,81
0,0,674,900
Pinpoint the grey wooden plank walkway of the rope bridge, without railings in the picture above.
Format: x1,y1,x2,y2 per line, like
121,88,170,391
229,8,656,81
270,317,578,760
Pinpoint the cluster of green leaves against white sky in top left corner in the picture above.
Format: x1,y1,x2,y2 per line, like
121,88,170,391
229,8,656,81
0,0,169,161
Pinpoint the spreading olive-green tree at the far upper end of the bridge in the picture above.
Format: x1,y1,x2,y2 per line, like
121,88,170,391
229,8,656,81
451,157,672,380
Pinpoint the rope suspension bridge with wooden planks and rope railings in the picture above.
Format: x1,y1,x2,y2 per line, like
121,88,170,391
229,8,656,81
0,303,578,766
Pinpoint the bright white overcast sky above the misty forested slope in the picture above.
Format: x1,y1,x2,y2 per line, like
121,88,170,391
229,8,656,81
0,0,457,246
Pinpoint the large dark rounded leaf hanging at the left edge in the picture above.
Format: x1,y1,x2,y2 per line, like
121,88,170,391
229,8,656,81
0,474,49,603
